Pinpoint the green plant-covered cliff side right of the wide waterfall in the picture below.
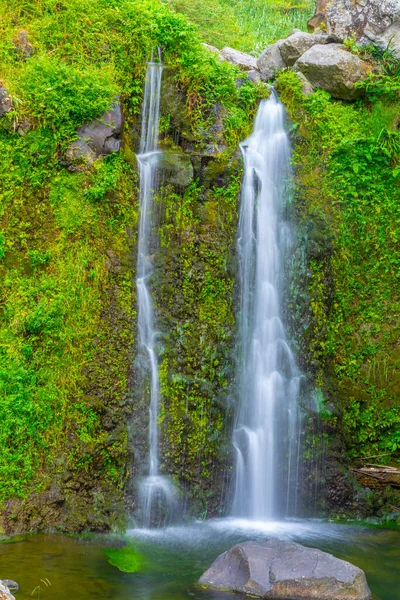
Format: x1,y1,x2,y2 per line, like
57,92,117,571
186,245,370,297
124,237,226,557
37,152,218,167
278,71,400,462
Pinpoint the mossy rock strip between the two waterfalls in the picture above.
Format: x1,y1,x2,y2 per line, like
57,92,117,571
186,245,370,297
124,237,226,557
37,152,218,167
132,67,268,516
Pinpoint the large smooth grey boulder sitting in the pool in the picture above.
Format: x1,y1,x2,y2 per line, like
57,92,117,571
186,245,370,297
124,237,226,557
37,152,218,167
199,540,371,600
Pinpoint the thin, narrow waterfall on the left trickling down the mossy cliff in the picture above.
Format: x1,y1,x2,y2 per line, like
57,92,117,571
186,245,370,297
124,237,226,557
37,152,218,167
136,61,176,527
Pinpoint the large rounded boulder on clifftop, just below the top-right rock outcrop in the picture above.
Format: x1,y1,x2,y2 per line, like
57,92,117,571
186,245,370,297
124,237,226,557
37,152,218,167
294,44,368,101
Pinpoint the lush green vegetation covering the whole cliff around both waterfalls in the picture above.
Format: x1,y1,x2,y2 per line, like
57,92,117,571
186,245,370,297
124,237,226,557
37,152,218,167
0,0,400,528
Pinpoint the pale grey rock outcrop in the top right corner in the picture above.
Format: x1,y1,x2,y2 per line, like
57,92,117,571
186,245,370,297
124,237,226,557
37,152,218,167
308,0,400,58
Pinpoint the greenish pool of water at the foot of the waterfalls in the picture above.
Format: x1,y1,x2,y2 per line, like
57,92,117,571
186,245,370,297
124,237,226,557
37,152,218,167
0,520,400,600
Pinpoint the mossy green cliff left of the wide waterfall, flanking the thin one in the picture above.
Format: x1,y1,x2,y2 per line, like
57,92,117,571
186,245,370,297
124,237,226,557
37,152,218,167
0,0,266,533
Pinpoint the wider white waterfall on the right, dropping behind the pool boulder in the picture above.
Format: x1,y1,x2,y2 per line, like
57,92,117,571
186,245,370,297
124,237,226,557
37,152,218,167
232,90,300,520
